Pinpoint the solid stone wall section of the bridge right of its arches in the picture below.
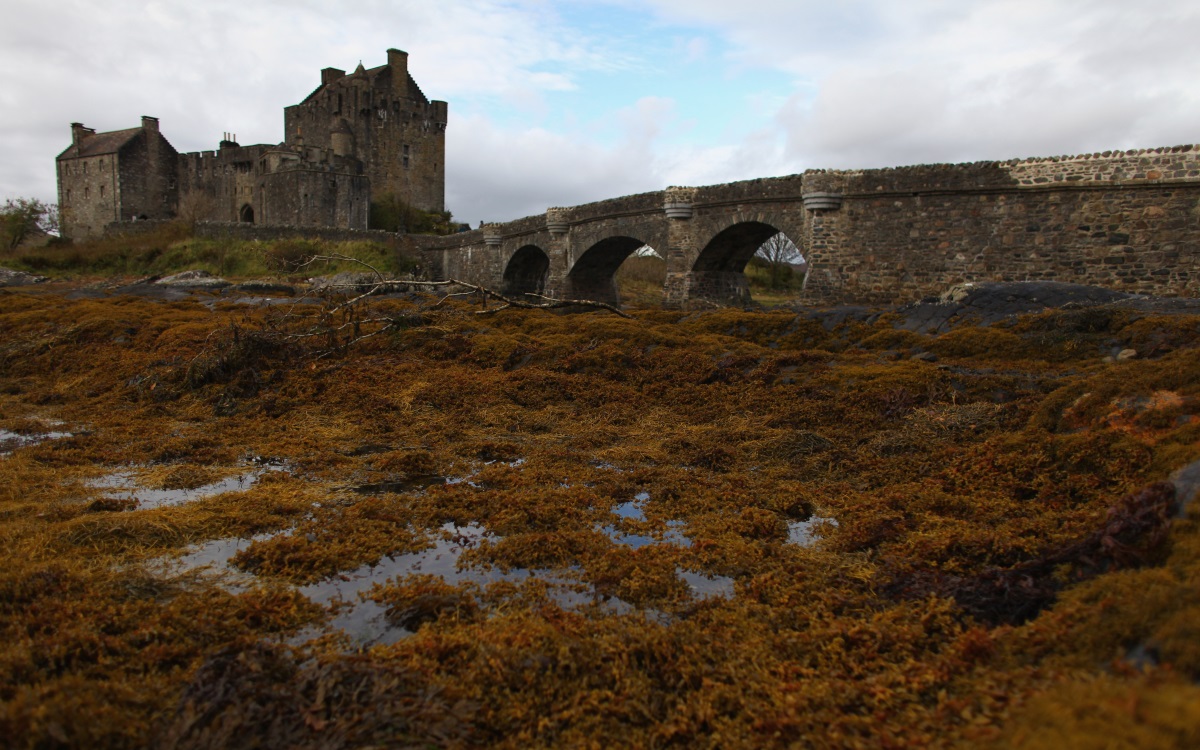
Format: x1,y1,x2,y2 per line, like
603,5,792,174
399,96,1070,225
804,146,1200,302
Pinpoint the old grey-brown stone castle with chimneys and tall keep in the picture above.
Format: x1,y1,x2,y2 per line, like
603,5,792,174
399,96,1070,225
56,49,446,238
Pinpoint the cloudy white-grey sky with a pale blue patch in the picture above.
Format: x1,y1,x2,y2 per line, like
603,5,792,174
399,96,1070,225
0,0,1200,226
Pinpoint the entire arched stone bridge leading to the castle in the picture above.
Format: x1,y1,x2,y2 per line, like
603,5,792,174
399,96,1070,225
414,145,1200,306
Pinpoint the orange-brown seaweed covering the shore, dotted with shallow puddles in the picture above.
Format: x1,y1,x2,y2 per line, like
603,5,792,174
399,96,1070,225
0,283,1200,748
